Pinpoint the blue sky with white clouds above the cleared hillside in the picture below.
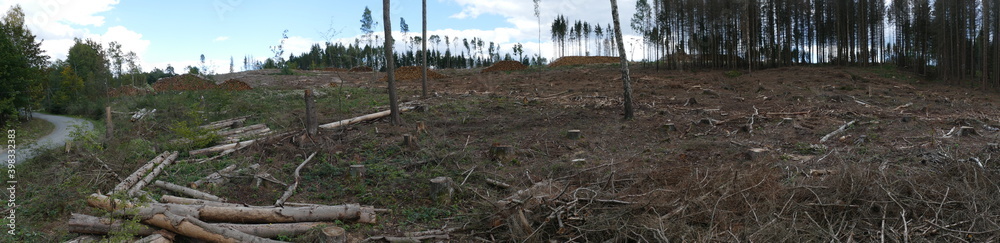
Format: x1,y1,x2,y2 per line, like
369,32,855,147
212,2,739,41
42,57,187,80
0,0,642,73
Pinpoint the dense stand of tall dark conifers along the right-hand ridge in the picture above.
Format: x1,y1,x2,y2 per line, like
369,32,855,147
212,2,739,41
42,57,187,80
616,0,1000,88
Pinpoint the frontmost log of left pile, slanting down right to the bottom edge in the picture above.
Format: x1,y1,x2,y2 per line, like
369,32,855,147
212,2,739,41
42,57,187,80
143,211,282,243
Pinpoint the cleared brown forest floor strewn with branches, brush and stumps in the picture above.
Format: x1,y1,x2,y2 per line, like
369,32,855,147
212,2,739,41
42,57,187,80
9,64,1000,242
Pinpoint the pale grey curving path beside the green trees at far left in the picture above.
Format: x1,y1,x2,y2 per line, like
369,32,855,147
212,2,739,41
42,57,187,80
0,113,94,163
